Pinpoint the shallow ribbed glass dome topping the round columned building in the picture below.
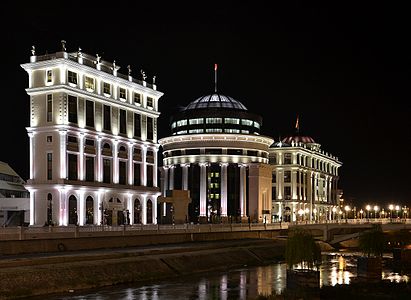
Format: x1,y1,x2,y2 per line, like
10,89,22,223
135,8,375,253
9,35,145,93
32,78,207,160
183,93,247,110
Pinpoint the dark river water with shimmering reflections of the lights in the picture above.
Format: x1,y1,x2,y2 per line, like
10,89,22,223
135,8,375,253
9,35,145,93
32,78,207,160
25,253,410,300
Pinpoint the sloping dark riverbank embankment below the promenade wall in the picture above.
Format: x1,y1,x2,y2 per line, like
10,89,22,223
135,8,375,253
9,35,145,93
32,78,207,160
0,238,286,300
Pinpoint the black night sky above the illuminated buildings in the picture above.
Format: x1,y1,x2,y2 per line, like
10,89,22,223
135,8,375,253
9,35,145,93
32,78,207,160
0,1,411,206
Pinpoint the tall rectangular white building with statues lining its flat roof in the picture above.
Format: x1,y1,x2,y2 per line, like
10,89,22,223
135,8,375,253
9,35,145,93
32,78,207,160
21,41,163,226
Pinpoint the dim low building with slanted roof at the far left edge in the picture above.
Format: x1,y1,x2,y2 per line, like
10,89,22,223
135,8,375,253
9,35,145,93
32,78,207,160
0,161,30,227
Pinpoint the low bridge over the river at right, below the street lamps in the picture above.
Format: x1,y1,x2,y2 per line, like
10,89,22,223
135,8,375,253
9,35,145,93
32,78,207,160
288,219,411,244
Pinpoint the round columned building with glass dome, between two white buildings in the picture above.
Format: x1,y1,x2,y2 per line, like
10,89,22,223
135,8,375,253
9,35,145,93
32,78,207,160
158,92,274,223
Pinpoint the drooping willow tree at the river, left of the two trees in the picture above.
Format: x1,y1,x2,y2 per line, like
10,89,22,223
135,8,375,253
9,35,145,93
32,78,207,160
285,227,321,270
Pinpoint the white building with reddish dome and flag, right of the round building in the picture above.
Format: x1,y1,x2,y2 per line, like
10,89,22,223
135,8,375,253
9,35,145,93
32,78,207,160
269,121,342,221
